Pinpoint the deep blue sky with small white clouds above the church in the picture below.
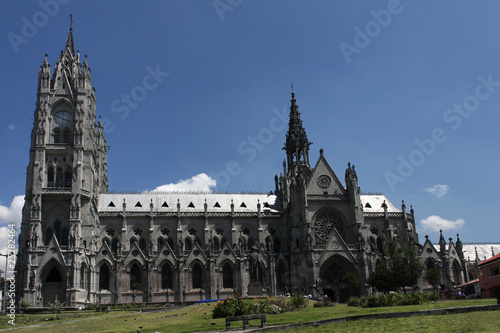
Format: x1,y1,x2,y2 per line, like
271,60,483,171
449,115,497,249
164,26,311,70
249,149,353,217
0,0,500,256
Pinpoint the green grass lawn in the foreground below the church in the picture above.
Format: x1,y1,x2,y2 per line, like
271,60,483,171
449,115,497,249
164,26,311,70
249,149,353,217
0,299,500,333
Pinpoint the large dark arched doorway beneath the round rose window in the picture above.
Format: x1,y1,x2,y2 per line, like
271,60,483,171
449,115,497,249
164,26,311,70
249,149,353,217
320,255,360,303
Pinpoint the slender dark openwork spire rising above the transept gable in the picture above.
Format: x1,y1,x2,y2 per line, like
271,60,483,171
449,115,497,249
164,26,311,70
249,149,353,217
283,84,311,168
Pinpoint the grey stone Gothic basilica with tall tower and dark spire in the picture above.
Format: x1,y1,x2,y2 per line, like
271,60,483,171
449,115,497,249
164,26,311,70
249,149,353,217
16,24,468,307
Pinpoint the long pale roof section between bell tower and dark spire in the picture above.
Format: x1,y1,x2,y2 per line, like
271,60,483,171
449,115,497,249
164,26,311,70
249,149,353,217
99,192,280,213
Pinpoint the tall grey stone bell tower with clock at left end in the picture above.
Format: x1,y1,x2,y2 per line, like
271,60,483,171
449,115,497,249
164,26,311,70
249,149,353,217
16,16,108,306
